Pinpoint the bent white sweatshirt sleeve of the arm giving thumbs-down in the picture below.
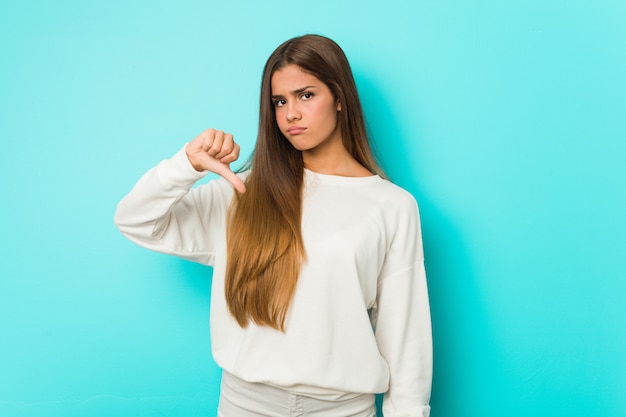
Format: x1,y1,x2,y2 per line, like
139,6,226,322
114,148,234,265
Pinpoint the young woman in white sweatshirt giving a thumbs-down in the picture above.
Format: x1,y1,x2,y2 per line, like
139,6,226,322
115,35,432,417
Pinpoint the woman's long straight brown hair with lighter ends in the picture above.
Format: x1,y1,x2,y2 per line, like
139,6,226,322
225,35,384,331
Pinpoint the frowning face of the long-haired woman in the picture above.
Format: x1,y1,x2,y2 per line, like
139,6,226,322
271,64,343,157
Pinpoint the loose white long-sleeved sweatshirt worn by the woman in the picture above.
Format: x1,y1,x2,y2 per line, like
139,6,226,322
115,145,432,417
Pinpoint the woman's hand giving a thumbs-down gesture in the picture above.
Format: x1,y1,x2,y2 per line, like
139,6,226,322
185,129,246,193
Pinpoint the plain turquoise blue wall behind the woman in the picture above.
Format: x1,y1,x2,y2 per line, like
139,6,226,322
0,0,626,417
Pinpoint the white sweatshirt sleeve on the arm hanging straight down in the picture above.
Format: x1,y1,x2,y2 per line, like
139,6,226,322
375,196,432,417
